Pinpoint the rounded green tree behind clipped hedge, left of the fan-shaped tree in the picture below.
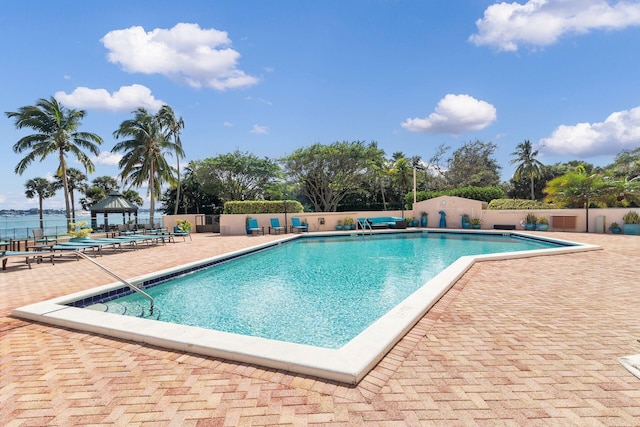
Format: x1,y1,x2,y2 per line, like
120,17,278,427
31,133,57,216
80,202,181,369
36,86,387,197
190,150,281,203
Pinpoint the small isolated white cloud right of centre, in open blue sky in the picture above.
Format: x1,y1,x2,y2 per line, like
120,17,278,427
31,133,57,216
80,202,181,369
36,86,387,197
401,94,496,134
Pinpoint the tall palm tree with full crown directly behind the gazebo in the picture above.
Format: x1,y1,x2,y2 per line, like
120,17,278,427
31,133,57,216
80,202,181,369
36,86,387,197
111,108,178,224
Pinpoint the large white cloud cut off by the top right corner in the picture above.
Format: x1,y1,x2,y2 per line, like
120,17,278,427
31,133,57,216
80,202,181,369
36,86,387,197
469,0,640,51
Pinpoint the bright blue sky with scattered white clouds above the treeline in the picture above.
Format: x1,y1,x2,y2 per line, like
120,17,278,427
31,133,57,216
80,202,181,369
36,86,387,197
0,0,640,209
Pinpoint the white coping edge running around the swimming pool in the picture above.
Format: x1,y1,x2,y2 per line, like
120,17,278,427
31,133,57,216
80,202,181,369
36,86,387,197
12,229,601,384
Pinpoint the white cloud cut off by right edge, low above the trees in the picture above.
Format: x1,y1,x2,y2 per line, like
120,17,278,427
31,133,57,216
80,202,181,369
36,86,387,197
540,107,640,156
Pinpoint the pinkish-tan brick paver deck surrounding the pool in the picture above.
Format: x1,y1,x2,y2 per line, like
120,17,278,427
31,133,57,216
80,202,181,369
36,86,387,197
0,233,640,426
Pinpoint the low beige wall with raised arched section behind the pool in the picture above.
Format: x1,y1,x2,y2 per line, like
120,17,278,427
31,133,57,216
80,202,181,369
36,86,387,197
218,196,640,235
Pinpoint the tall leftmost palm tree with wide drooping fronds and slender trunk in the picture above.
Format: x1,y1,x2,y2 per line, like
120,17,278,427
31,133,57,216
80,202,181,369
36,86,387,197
5,97,102,228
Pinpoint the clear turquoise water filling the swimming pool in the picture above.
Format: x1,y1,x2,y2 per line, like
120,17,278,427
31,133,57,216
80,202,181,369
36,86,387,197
97,233,557,348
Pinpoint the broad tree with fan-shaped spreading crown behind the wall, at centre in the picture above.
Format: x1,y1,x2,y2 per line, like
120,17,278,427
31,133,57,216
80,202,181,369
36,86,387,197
282,141,384,212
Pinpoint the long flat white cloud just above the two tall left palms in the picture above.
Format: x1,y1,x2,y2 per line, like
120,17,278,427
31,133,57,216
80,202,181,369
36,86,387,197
54,84,164,111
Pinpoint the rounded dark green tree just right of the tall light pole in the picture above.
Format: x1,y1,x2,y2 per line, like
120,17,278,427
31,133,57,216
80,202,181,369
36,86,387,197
444,140,502,188
